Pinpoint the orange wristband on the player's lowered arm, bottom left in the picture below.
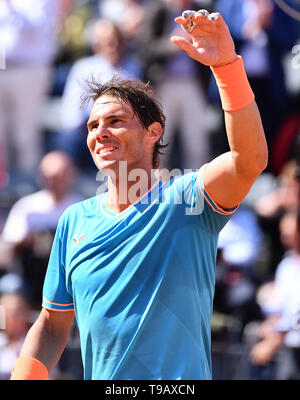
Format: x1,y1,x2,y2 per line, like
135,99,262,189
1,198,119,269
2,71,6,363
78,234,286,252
10,357,48,380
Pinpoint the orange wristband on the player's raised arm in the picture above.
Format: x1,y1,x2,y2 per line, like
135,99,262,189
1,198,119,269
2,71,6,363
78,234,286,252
211,56,254,111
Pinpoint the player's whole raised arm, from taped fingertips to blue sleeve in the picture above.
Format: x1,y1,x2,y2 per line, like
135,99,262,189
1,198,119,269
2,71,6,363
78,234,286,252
171,10,268,209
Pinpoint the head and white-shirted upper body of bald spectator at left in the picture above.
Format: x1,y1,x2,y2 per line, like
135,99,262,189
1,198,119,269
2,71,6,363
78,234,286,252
2,150,82,245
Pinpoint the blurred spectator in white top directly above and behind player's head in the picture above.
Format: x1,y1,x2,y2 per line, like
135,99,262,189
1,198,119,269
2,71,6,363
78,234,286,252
55,19,141,167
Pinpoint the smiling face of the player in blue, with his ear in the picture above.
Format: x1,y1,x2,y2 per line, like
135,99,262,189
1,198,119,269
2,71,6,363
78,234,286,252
87,94,159,173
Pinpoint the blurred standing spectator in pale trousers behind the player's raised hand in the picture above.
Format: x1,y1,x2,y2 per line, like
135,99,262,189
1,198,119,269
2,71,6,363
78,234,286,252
139,0,209,168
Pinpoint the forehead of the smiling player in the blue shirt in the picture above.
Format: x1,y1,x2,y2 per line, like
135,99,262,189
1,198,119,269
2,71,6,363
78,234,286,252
91,95,134,118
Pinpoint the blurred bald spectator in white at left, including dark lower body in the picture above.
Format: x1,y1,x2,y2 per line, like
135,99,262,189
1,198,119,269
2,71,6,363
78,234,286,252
2,151,81,307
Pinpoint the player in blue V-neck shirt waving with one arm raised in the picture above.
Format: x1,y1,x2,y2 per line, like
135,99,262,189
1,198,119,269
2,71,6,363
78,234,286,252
12,10,267,379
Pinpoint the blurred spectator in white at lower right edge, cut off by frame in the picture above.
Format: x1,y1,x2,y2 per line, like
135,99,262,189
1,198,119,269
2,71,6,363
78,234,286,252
251,210,300,379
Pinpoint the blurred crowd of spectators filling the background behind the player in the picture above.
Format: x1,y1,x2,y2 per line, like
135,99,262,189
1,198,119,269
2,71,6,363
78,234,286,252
0,0,300,379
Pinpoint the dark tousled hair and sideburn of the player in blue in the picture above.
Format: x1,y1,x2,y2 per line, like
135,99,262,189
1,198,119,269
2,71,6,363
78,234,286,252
81,75,167,167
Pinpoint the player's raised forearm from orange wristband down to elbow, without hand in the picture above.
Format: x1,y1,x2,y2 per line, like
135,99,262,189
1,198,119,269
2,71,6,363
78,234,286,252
211,56,268,179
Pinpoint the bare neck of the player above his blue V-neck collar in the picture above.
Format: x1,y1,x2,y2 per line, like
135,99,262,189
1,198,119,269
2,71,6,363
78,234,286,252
107,164,158,214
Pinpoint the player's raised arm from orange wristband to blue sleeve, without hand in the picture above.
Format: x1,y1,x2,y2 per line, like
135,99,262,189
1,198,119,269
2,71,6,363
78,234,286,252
204,59,268,209
